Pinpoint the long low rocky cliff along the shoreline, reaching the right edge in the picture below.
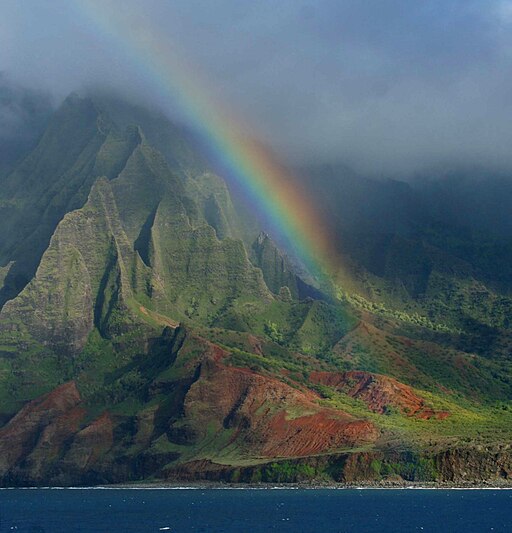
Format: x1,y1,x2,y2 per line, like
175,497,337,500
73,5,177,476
166,448,512,487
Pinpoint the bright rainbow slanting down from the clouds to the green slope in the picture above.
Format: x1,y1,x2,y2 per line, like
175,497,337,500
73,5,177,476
70,0,341,278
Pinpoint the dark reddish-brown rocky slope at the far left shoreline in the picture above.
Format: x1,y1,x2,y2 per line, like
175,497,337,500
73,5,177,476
0,382,117,485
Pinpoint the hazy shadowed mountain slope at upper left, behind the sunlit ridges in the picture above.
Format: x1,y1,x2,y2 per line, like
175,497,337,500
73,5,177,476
0,95,140,307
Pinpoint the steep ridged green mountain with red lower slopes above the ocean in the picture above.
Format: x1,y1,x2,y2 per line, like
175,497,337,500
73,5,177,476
0,95,512,485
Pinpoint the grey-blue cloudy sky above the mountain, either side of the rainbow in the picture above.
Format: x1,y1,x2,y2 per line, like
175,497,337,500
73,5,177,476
0,0,512,178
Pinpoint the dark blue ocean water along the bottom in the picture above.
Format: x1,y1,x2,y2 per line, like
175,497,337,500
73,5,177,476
0,489,512,533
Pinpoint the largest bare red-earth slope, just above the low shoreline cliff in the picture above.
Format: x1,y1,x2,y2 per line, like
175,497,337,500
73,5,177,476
185,360,379,457
